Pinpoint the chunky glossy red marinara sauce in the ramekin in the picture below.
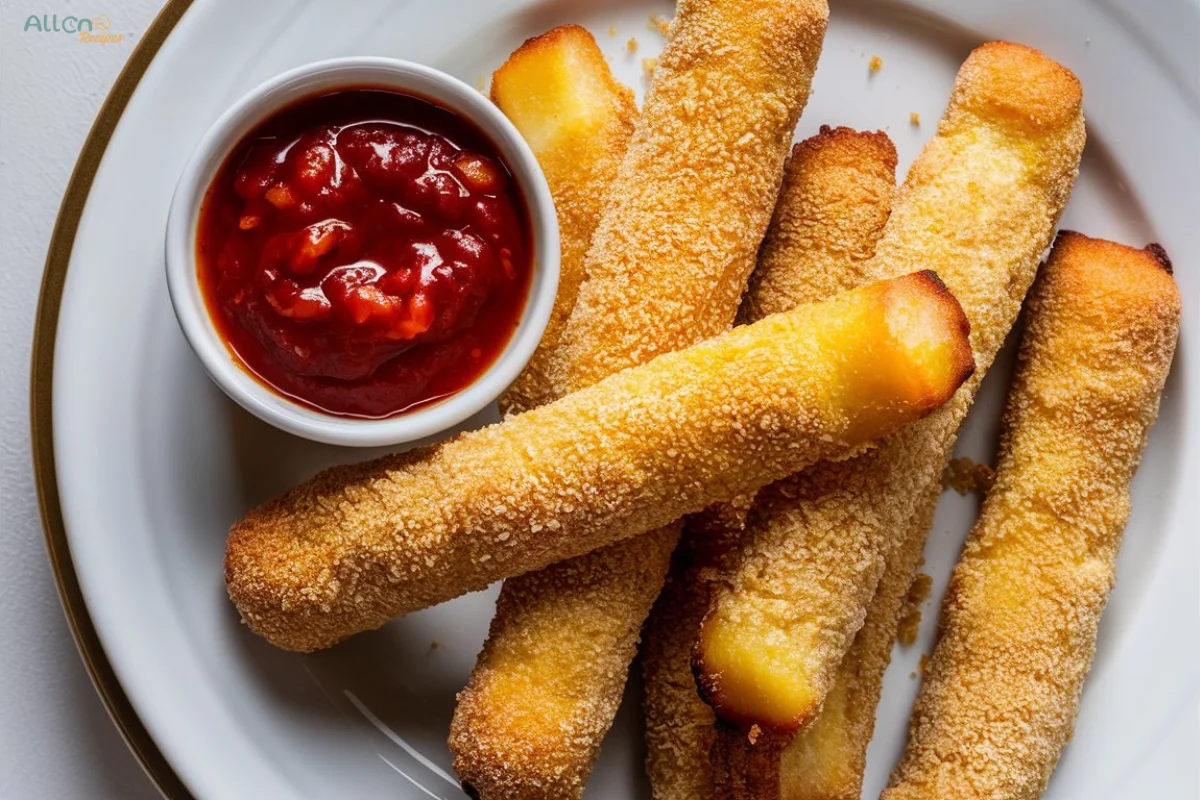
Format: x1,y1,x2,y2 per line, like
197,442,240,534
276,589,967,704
196,86,533,417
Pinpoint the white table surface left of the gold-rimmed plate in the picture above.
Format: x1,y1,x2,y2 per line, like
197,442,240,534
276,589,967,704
0,0,1196,800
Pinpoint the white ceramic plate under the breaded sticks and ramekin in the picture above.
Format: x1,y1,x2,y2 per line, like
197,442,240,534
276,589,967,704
35,0,1200,800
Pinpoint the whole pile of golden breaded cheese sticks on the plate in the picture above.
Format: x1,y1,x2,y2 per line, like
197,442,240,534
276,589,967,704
226,0,1178,800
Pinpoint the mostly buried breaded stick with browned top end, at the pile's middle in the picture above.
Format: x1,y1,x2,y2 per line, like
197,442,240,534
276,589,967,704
642,128,896,800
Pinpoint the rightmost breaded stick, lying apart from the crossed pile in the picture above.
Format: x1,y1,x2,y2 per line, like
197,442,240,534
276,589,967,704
883,234,1181,800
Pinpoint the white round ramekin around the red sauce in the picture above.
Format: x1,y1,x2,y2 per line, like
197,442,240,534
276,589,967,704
167,56,559,447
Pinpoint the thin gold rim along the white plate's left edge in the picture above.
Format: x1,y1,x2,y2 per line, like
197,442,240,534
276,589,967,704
29,0,192,800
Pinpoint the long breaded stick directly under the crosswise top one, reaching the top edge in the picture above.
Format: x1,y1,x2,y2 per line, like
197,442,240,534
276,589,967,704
450,0,828,800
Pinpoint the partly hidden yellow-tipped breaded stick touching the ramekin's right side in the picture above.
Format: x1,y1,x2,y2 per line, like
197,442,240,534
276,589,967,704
492,25,637,414
